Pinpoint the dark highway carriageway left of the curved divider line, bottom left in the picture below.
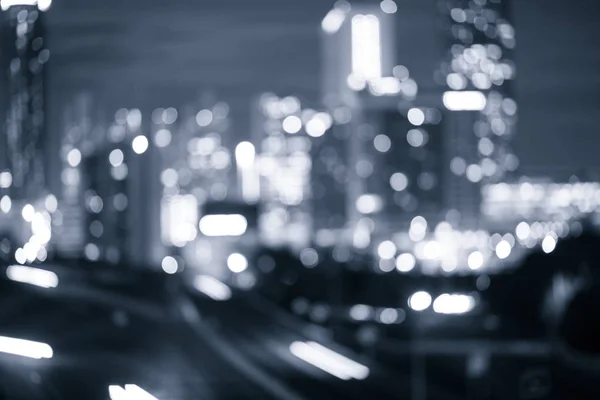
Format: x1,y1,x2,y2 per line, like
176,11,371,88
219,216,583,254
0,262,274,400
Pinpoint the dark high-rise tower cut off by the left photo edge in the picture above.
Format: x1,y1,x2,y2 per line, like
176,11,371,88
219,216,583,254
0,0,52,199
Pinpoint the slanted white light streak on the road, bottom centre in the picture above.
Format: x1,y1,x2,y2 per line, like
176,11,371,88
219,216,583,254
290,342,369,380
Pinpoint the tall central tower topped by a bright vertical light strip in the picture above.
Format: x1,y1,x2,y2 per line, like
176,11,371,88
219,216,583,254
322,1,449,247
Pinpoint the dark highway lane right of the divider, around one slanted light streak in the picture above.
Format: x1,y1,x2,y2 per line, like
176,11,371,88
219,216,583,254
185,284,462,399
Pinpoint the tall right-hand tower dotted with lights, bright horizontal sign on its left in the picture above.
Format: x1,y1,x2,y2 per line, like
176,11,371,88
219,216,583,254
437,0,518,225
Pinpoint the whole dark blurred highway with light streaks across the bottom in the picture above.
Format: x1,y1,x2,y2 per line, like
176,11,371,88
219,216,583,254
0,265,592,400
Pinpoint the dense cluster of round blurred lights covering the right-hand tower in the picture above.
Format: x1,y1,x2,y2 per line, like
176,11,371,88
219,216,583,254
442,2,518,183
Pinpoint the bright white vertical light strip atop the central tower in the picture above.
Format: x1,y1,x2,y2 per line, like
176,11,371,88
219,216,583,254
352,14,381,81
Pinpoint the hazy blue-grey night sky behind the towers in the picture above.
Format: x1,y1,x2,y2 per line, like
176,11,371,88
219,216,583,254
47,0,600,177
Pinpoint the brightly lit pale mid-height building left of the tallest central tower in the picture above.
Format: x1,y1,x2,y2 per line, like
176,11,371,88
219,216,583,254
252,94,314,248
